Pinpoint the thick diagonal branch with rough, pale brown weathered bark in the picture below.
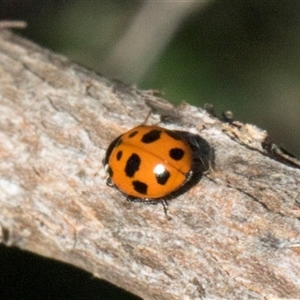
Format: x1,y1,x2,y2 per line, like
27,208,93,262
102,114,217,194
0,30,300,300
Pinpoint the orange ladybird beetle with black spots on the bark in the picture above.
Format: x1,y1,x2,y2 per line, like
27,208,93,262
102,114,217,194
103,125,208,219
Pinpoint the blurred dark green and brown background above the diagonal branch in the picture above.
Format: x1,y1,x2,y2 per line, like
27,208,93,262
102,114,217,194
0,0,300,299
